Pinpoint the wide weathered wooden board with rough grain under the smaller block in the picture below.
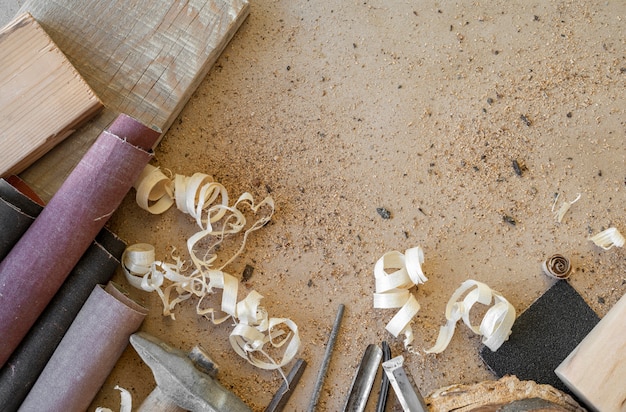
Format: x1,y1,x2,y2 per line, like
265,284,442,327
21,0,249,199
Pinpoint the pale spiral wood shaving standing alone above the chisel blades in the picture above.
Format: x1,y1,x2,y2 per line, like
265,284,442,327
374,246,428,349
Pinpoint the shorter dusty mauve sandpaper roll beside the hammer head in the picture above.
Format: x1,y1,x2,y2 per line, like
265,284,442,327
19,283,147,412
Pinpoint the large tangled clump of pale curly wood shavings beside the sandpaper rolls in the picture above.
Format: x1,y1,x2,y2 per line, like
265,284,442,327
122,167,300,373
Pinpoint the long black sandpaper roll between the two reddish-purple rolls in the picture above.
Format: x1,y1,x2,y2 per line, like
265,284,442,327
0,228,126,412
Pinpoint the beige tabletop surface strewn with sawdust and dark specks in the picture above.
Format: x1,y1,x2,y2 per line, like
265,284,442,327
93,0,626,411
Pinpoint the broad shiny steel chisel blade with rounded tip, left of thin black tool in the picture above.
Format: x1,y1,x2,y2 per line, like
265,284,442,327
343,344,383,412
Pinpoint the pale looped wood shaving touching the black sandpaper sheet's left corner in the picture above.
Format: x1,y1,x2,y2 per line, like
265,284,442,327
426,279,515,353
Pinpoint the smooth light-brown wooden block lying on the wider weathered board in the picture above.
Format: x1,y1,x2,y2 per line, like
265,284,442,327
0,13,102,177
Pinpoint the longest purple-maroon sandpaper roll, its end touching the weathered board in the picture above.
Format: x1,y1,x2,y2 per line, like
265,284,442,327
0,115,160,366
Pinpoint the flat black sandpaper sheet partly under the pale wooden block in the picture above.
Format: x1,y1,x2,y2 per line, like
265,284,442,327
480,280,600,394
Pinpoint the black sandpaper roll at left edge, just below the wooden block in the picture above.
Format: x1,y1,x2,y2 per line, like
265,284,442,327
0,179,42,260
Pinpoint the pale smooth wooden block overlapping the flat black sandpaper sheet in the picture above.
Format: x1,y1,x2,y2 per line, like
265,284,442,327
555,295,626,412
